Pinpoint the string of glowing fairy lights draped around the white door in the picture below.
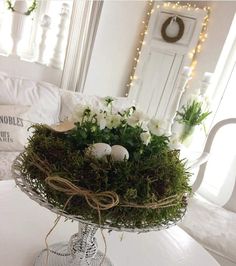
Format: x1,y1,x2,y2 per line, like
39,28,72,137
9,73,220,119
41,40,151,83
125,0,211,97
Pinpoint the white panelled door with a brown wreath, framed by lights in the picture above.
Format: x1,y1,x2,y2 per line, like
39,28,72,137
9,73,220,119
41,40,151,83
128,2,205,119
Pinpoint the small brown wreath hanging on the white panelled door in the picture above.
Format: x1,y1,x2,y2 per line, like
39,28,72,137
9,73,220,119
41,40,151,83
161,16,184,43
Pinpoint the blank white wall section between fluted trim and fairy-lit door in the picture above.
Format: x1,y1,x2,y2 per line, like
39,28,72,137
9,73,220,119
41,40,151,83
84,1,147,96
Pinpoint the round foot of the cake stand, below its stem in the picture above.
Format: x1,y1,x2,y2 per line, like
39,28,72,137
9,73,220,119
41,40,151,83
34,243,113,266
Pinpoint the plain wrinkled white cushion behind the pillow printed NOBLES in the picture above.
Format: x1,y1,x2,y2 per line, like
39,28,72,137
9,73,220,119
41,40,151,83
0,73,61,124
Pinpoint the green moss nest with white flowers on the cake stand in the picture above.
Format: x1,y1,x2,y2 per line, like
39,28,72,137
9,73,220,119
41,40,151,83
18,101,191,228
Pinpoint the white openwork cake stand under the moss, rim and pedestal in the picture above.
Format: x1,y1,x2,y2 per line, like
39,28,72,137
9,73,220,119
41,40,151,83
12,158,186,266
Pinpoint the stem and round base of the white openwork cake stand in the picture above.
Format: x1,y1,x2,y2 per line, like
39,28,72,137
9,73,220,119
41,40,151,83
34,222,113,266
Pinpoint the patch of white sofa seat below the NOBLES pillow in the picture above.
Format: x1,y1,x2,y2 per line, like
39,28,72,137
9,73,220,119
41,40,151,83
0,151,19,180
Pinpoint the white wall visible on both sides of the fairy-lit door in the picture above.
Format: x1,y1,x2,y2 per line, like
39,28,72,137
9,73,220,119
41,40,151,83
85,1,236,96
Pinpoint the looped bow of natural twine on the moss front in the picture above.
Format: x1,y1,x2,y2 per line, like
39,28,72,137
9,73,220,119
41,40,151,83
45,176,119,210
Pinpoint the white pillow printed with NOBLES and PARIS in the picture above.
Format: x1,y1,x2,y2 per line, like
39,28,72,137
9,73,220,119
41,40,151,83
0,105,32,151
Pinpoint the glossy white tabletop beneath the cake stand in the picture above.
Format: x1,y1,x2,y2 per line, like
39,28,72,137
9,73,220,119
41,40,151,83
0,181,219,266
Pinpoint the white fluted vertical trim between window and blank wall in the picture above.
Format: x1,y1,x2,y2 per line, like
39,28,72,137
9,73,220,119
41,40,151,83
61,0,103,92
